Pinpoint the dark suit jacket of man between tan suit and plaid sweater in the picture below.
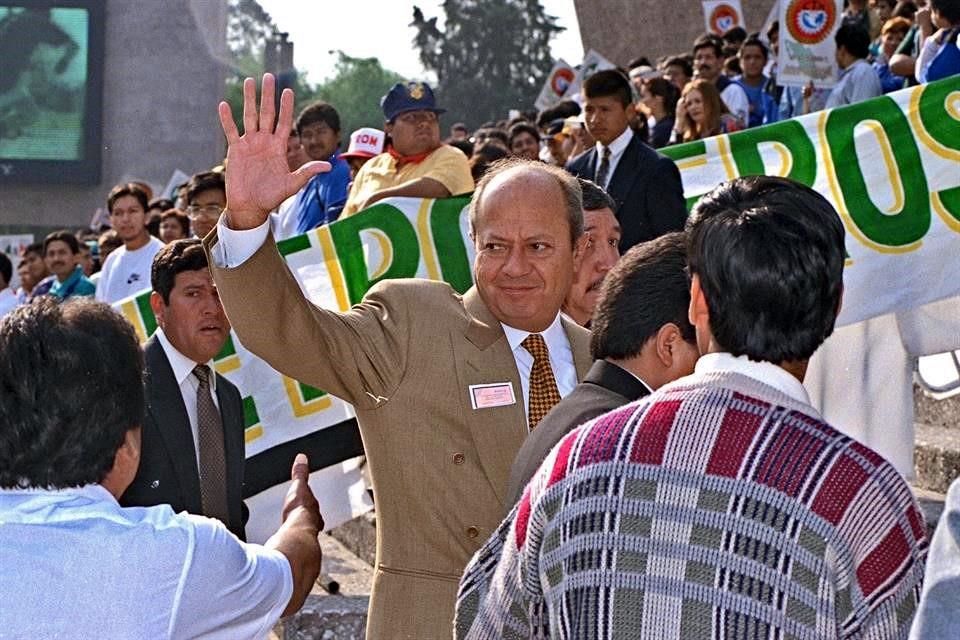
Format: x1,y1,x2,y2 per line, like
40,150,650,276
506,360,650,512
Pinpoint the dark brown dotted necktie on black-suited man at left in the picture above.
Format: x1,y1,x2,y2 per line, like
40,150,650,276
193,364,229,523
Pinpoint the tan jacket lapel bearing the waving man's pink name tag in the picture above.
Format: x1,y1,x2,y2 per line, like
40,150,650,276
454,287,527,503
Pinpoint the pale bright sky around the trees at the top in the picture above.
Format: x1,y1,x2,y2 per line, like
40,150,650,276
259,0,583,83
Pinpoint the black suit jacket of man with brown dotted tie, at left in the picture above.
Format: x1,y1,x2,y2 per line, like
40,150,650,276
120,337,247,540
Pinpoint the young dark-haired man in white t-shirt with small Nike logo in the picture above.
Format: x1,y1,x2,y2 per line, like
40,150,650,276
96,182,163,304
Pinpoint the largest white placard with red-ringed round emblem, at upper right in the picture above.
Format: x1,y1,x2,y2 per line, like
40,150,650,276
777,0,843,89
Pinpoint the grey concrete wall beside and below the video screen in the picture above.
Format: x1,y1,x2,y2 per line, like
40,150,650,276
0,0,227,232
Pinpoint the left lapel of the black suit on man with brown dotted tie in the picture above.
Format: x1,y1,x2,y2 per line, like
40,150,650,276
144,338,203,513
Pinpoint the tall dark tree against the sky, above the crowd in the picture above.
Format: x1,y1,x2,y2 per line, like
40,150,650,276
411,0,563,126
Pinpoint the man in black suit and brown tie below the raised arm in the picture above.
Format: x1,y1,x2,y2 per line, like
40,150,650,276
120,239,247,540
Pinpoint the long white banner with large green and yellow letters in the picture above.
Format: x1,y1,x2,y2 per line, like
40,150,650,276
117,76,960,539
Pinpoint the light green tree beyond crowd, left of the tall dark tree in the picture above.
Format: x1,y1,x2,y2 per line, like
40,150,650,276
314,51,404,141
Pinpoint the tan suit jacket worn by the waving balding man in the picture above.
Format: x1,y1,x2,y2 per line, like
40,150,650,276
205,234,592,640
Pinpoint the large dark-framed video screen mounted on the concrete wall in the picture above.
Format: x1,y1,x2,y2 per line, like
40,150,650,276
0,0,104,184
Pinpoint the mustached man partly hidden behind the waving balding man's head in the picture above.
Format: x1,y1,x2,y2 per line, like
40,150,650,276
560,178,620,328
